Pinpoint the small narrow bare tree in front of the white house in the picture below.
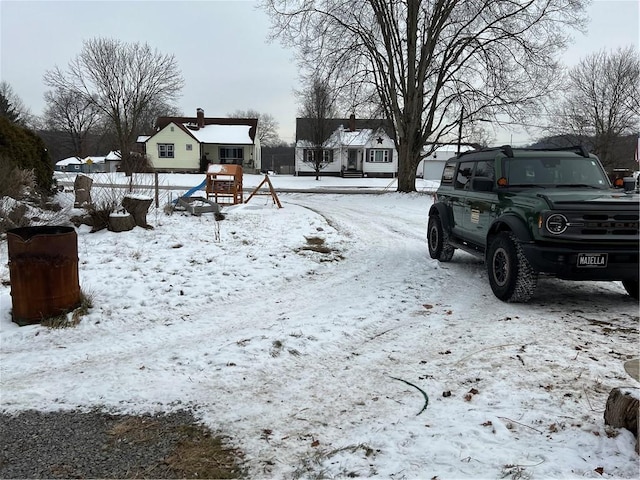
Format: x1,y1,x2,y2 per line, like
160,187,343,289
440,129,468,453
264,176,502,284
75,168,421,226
298,78,336,180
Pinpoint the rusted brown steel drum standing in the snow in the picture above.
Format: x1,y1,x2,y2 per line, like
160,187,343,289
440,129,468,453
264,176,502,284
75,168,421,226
7,226,80,325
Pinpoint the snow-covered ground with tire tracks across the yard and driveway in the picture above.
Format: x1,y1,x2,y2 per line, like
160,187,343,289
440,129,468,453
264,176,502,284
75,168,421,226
0,174,640,480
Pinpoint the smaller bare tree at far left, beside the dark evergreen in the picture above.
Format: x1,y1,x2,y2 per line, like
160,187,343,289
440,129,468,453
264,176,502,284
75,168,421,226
43,88,100,158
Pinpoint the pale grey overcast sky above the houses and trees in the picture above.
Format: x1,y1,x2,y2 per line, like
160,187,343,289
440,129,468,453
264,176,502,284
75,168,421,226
0,0,640,144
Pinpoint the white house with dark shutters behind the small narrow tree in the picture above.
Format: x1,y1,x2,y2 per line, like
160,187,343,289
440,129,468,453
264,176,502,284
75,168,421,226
295,115,398,178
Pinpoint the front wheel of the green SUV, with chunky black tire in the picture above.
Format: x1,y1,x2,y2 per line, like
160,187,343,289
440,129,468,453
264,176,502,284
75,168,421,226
487,232,538,302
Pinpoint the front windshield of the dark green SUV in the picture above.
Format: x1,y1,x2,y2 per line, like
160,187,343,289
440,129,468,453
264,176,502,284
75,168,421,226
504,157,609,188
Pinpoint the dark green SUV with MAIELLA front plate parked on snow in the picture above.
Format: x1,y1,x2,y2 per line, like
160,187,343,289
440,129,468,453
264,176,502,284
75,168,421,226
427,145,640,302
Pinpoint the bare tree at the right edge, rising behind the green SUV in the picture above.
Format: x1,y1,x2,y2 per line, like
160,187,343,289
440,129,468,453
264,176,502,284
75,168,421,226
549,46,640,168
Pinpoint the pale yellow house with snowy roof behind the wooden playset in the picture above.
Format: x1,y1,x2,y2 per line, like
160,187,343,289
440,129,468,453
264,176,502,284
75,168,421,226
138,108,262,172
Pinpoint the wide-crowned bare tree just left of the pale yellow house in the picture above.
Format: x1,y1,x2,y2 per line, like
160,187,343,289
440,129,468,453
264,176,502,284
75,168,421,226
44,38,184,173
